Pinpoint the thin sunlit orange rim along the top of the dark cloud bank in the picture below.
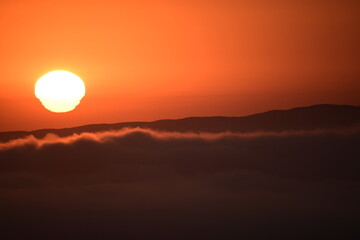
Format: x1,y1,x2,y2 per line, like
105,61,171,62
0,127,360,151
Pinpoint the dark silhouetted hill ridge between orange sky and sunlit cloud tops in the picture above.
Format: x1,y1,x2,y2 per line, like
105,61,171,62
0,104,360,142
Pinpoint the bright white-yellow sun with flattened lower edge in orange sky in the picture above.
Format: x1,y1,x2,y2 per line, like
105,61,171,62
35,70,85,113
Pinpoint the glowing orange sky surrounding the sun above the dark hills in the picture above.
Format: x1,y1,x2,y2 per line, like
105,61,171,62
0,0,360,131
